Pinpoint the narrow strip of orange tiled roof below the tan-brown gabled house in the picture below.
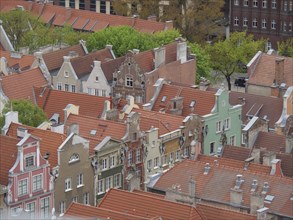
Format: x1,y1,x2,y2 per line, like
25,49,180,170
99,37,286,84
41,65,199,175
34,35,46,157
64,202,150,220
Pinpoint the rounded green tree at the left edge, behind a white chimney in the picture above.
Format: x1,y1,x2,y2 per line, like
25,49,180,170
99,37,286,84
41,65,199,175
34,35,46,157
0,100,47,127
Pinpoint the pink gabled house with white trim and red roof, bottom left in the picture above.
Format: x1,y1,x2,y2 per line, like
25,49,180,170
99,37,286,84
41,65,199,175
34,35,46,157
0,133,54,219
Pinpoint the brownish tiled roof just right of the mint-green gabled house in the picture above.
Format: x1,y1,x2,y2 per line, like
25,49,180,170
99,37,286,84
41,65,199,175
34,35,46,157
229,91,283,129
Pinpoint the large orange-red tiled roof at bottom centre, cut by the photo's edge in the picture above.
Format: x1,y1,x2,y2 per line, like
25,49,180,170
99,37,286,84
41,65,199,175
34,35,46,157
98,188,204,220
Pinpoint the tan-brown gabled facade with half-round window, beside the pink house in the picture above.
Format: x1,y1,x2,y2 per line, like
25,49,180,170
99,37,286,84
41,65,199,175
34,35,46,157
52,133,95,214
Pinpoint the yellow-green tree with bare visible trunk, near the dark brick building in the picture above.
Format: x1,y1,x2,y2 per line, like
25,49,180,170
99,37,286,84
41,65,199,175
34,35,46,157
207,32,265,90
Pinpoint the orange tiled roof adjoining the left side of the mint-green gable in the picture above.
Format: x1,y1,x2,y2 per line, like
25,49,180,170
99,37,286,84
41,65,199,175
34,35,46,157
152,84,215,116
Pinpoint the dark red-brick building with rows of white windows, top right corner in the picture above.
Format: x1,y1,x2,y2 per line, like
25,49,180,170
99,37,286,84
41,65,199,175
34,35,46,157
229,0,293,50
